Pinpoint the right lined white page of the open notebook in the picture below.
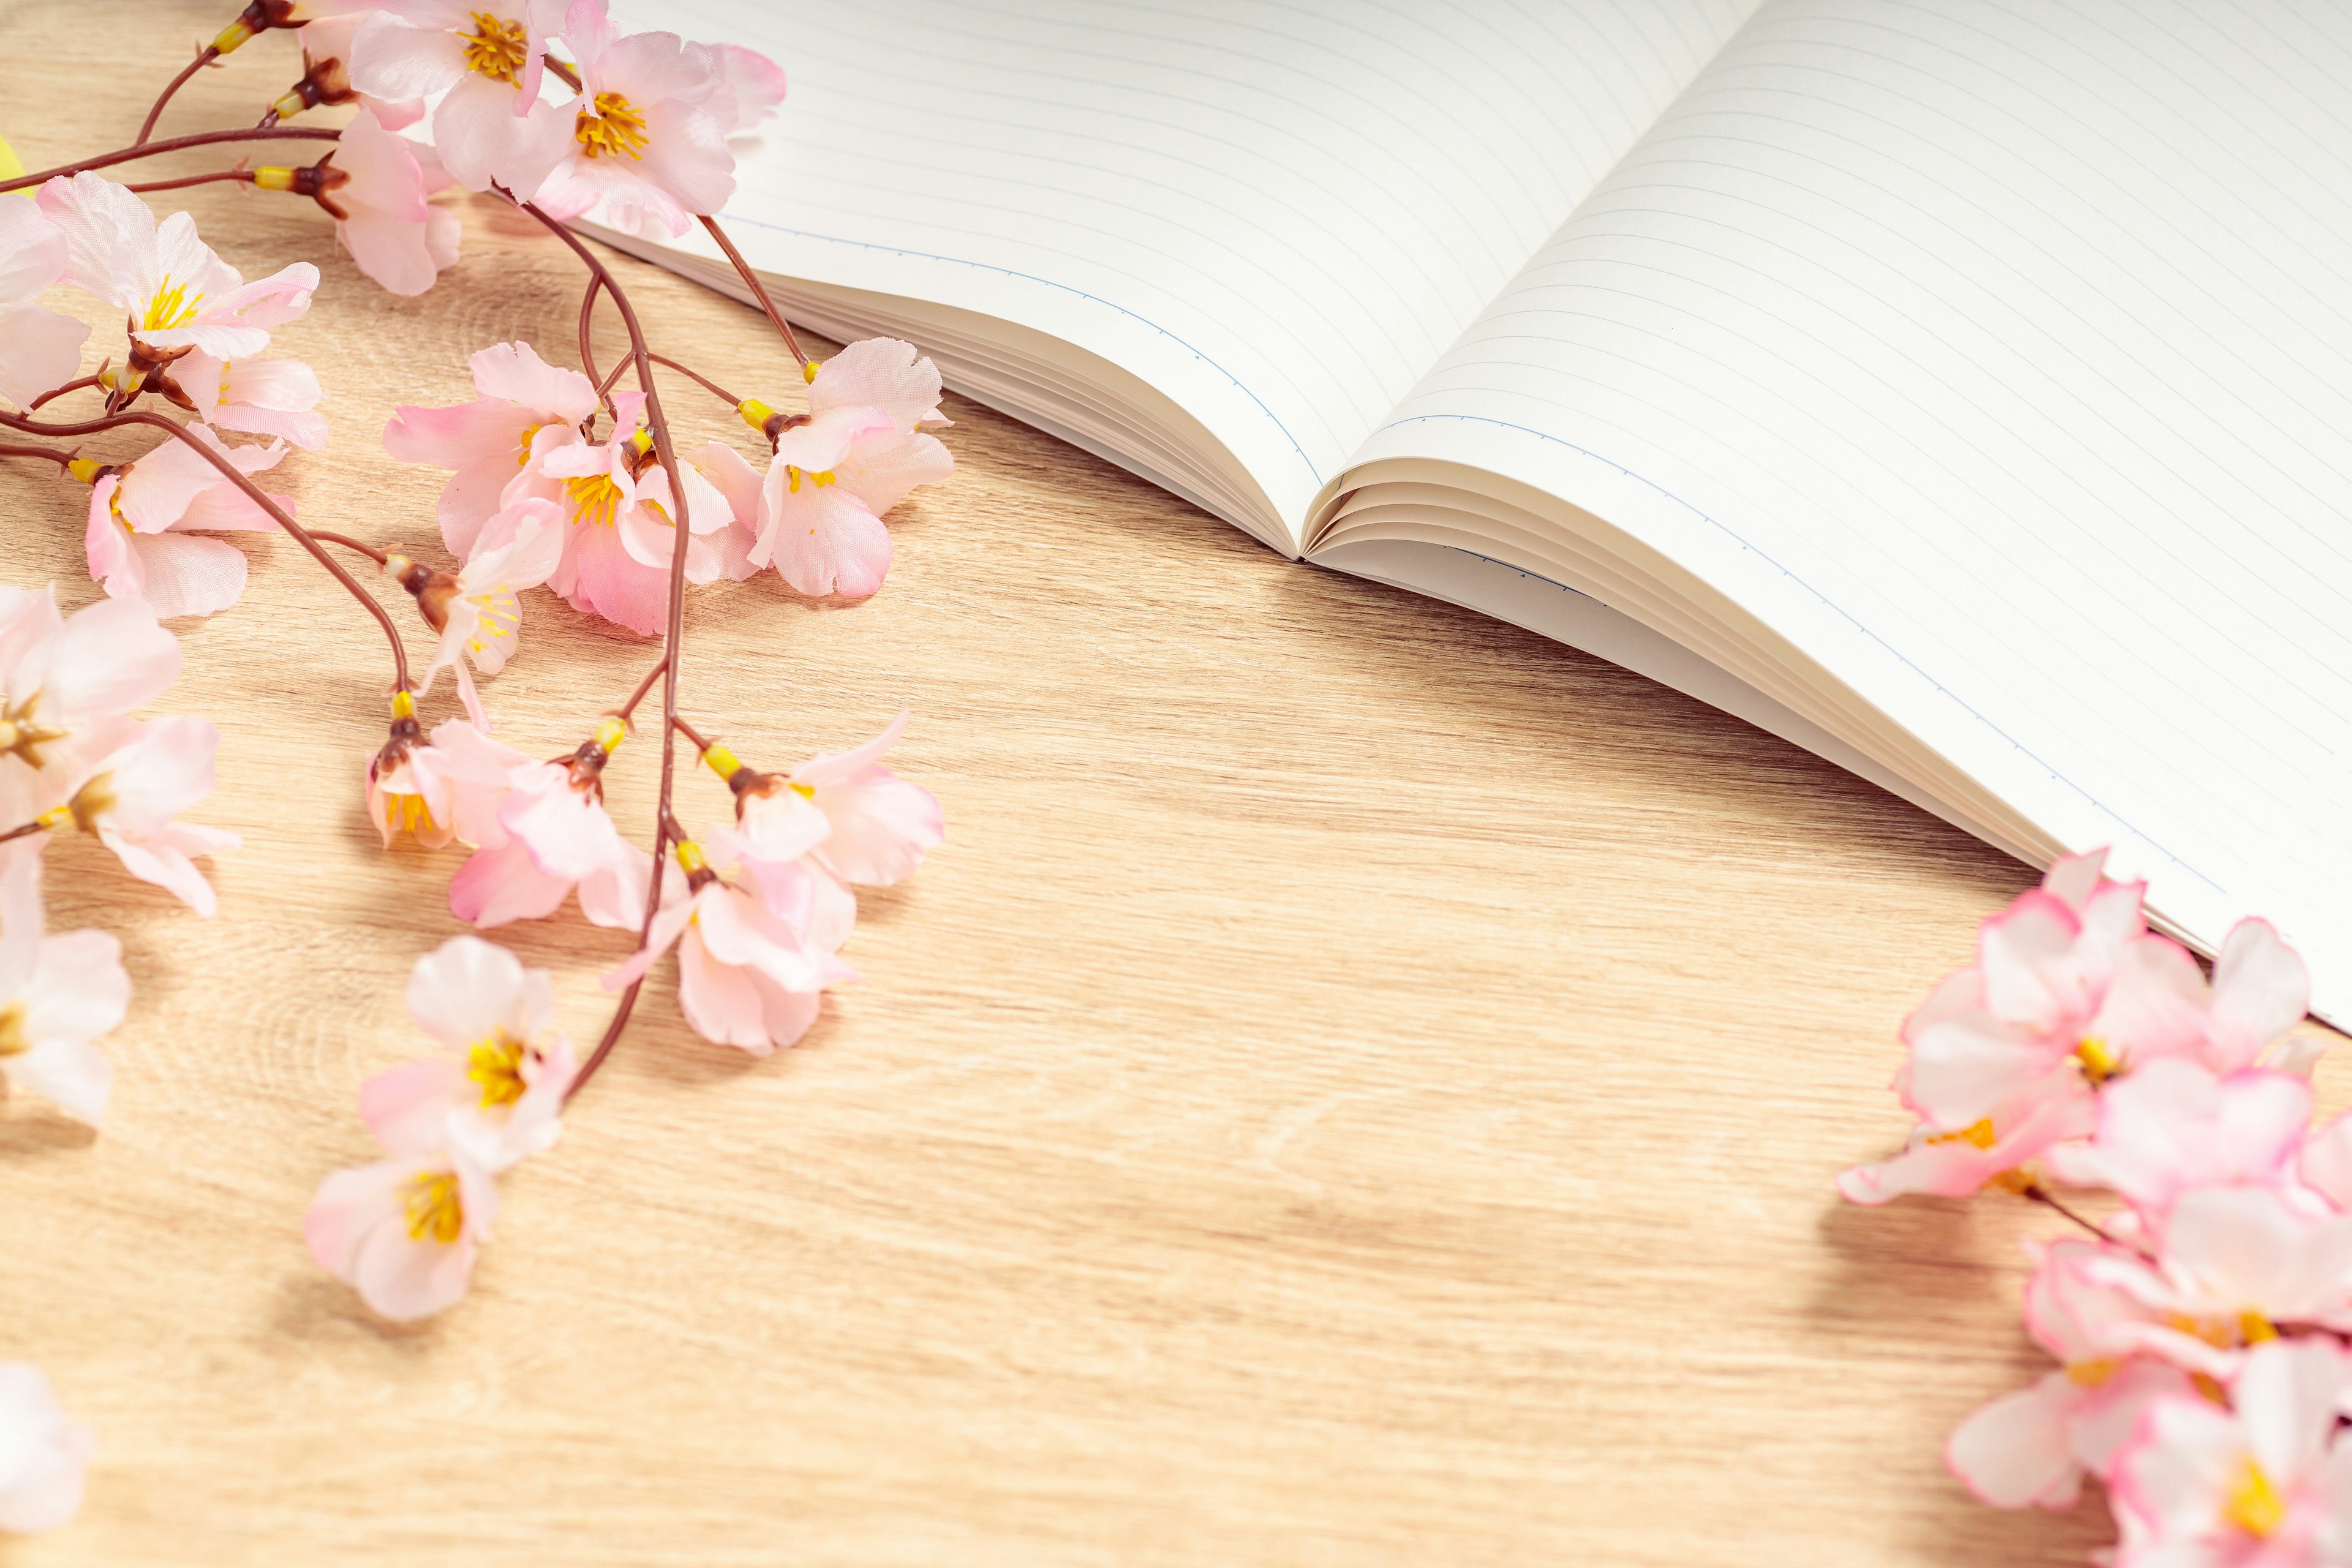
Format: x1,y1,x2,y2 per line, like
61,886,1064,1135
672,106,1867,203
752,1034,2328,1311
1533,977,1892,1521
1360,0,2352,1016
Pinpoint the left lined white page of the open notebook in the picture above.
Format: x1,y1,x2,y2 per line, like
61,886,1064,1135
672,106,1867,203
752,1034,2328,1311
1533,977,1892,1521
614,0,1752,536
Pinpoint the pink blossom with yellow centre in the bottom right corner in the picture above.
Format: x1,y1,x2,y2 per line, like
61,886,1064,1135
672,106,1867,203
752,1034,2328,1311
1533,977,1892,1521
2114,1340,2352,1568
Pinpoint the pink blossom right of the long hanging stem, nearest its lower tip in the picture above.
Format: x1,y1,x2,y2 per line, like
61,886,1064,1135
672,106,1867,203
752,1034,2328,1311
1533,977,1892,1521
605,827,856,1055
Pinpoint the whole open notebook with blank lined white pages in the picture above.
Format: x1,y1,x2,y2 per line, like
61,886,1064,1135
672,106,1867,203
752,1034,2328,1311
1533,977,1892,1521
592,0,2352,1020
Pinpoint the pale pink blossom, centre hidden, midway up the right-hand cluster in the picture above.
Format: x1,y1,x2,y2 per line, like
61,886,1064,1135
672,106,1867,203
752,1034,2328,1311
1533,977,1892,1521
2051,1058,2312,1229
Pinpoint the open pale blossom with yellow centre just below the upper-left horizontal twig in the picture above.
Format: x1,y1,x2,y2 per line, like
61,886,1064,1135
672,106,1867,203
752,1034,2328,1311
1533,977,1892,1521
40,169,317,360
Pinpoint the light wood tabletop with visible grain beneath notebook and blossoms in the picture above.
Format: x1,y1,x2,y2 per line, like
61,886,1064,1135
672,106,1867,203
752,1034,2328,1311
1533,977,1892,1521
0,0,2314,1568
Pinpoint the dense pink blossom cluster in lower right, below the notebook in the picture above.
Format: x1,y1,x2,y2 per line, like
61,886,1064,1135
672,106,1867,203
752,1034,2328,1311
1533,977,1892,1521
1839,853,2352,1568
